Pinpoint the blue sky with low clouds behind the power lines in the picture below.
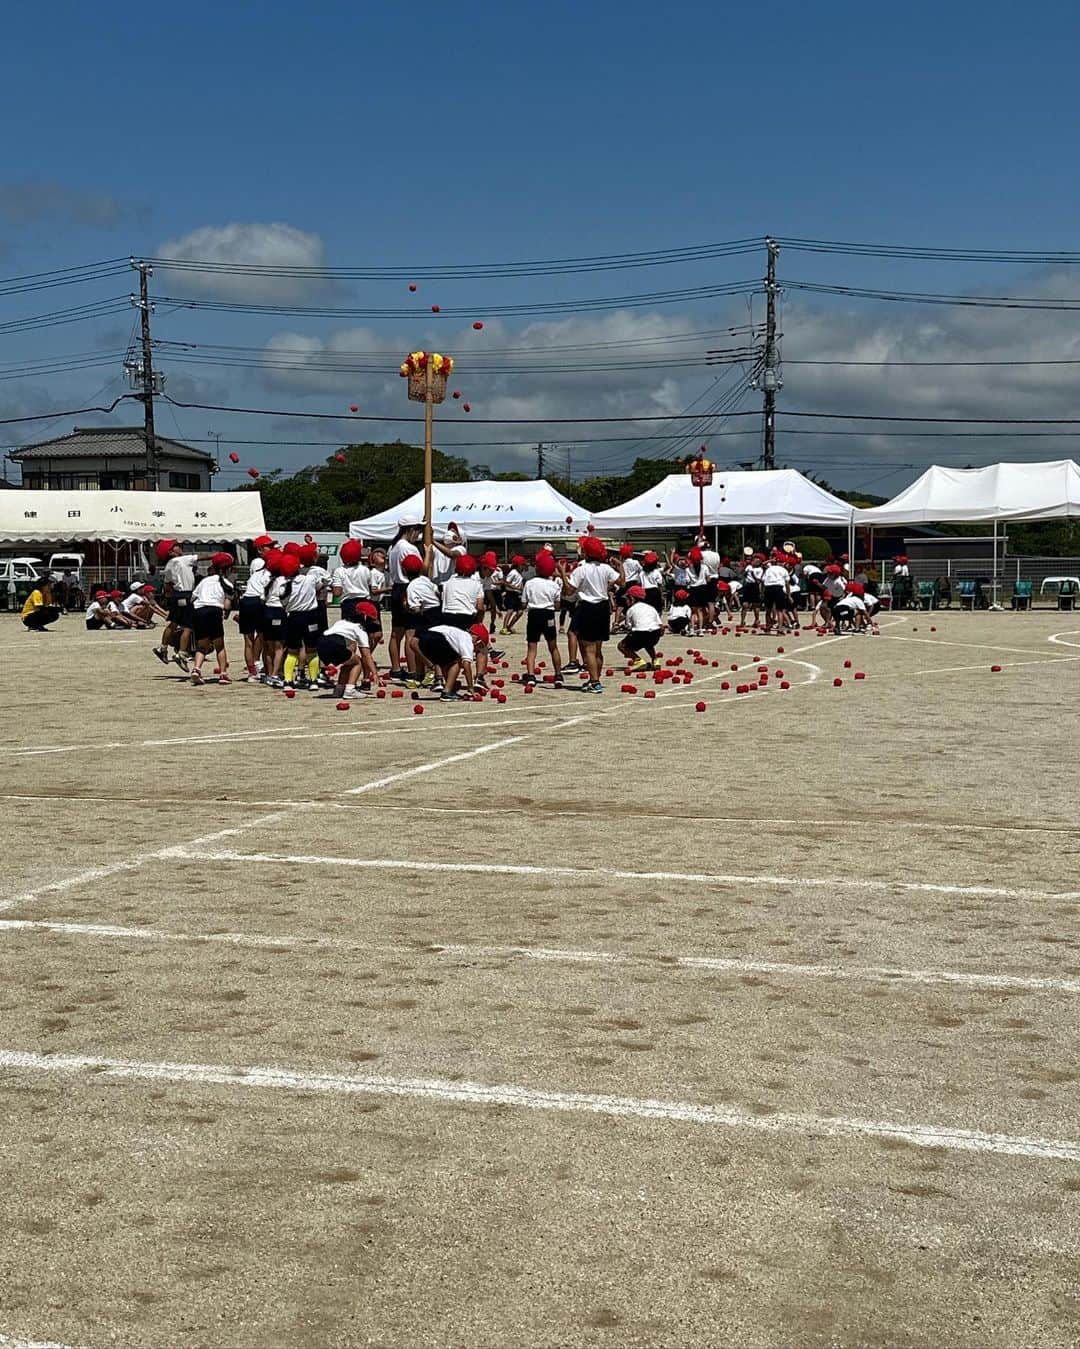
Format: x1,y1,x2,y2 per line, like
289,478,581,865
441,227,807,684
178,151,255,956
0,0,1080,492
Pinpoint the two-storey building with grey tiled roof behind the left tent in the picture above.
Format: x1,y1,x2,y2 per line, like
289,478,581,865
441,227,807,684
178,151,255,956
7,426,217,492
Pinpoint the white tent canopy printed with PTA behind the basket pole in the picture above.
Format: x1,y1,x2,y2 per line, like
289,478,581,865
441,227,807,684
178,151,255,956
349,478,589,540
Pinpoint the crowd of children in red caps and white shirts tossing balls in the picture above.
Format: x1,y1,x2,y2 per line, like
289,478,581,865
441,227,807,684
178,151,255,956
109,517,878,700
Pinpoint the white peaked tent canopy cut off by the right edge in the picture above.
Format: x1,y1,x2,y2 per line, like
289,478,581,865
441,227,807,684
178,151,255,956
855,459,1080,525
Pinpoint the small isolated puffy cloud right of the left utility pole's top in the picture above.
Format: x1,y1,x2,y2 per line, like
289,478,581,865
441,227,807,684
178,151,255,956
158,223,333,304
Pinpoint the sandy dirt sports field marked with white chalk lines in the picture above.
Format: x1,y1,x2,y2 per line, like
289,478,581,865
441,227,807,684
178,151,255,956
0,612,1080,1349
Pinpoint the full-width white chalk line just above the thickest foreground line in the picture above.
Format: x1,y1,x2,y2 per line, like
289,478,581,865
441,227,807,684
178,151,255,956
0,919,1080,996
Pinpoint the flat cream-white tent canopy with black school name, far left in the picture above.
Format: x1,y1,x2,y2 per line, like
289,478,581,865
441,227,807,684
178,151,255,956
0,491,266,544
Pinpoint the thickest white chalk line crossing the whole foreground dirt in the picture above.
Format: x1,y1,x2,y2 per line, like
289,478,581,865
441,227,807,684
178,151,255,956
0,1050,1080,1161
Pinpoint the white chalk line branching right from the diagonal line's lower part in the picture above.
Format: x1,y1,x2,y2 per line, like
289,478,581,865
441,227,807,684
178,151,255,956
167,847,1080,900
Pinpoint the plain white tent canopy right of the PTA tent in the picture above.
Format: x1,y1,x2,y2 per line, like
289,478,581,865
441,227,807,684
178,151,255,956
592,468,852,532
